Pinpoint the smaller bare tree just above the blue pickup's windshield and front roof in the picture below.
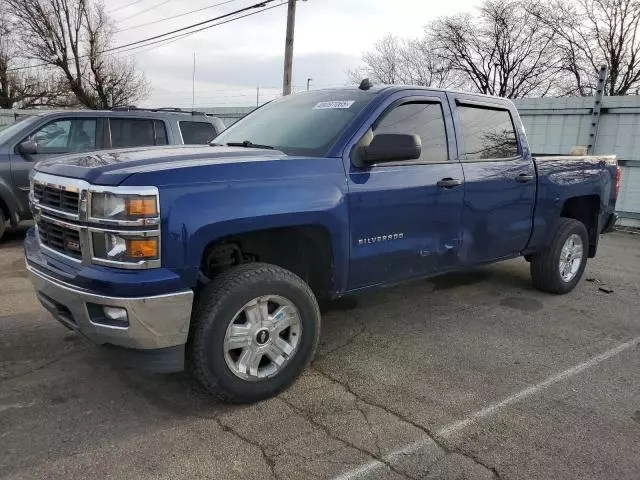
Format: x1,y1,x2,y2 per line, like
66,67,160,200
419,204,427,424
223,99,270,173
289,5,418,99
349,34,458,88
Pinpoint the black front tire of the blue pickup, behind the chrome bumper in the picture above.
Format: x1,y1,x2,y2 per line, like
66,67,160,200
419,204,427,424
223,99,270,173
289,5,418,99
187,263,320,403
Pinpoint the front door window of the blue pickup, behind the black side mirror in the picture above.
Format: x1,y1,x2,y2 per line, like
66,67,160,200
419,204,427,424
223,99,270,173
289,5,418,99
361,102,449,163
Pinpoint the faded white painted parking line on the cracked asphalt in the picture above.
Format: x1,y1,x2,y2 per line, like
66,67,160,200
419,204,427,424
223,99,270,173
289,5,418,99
334,337,640,480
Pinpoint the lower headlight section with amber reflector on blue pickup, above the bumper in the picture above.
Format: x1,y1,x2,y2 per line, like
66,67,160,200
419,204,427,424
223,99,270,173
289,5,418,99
92,232,160,263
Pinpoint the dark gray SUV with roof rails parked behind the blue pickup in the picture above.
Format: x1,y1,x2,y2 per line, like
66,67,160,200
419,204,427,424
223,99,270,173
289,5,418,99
0,108,224,239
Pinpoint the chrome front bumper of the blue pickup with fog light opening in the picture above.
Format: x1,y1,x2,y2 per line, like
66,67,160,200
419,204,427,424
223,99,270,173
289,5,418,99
27,264,193,350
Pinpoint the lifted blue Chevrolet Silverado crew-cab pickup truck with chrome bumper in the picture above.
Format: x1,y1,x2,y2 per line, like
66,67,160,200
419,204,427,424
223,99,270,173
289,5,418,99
25,82,620,402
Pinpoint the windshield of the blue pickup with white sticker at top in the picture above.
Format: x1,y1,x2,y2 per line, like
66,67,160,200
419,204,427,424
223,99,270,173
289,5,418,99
213,90,375,157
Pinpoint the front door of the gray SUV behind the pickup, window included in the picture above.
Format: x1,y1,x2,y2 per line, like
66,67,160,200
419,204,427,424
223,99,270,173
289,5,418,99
11,117,102,195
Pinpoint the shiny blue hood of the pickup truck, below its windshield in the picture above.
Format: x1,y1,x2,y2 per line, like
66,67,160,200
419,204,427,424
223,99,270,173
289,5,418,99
35,145,286,185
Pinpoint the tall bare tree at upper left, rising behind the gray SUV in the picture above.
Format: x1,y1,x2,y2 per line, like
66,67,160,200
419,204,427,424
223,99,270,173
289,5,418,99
4,0,148,109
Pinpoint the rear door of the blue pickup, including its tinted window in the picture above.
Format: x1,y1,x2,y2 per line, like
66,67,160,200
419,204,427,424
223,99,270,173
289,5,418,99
450,94,536,264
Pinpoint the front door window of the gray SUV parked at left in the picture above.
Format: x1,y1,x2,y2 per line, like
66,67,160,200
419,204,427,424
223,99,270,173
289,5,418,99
29,118,97,154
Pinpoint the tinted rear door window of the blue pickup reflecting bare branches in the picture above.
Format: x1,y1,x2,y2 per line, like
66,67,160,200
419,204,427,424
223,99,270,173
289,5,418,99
458,104,518,160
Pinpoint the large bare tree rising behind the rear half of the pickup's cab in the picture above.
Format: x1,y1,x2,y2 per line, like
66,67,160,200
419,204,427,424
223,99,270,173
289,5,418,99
426,0,560,98
